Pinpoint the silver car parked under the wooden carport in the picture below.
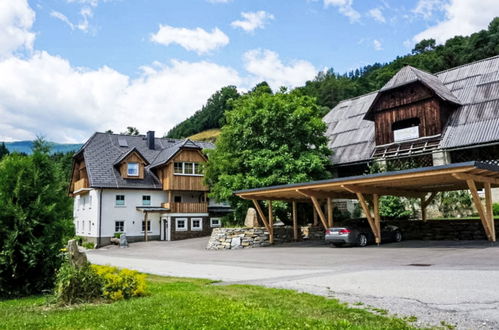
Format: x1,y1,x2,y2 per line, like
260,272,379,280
325,219,402,247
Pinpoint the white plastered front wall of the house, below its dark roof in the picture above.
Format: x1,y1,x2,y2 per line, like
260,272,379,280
101,189,167,237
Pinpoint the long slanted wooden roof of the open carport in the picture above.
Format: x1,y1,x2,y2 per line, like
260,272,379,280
234,162,499,201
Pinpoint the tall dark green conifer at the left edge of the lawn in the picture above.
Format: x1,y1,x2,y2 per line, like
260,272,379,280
0,140,73,297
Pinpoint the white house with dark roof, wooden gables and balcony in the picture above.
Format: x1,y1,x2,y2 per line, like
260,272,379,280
70,132,231,246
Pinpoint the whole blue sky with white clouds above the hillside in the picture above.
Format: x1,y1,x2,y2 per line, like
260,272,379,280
0,0,499,142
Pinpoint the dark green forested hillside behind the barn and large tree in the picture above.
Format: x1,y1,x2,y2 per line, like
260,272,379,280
167,17,499,138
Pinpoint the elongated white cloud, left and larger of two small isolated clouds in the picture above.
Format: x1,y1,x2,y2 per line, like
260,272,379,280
151,25,229,54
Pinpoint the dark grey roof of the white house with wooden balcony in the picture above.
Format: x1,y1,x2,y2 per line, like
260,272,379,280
80,133,214,189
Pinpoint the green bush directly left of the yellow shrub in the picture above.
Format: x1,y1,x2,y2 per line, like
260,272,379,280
54,262,103,305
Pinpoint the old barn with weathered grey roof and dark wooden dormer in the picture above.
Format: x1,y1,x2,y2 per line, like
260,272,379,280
324,56,499,200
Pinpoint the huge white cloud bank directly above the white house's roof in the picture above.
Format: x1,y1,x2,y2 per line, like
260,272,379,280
0,52,241,142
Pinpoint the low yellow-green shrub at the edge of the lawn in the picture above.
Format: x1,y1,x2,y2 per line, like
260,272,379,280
92,265,146,300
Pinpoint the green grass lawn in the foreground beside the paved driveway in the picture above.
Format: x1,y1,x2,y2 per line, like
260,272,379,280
0,276,418,329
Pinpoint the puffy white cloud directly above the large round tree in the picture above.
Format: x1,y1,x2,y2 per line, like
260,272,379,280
243,49,317,90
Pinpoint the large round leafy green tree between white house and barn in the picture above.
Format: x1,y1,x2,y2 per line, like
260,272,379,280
206,88,330,219
